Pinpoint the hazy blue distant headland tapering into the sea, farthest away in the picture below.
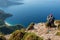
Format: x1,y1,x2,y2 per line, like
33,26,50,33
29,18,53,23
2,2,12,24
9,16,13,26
0,0,23,7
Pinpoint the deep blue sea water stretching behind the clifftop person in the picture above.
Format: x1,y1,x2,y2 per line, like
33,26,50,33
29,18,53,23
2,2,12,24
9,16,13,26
1,0,60,27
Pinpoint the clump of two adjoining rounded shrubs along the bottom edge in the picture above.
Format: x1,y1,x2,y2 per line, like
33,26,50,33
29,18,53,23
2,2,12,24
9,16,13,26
9,29,43,40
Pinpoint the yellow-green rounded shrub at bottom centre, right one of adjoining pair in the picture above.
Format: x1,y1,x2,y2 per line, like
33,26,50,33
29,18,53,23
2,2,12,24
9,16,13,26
22,33,43,40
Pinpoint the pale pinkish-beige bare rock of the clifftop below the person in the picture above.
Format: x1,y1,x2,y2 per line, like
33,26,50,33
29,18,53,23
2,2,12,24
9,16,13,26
27,23,60,40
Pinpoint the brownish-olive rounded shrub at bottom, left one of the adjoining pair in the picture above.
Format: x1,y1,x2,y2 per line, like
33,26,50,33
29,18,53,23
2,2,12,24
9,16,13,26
9,30,25,40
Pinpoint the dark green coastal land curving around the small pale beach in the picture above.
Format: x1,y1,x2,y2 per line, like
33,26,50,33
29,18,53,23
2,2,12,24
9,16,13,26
0,10,23,34
